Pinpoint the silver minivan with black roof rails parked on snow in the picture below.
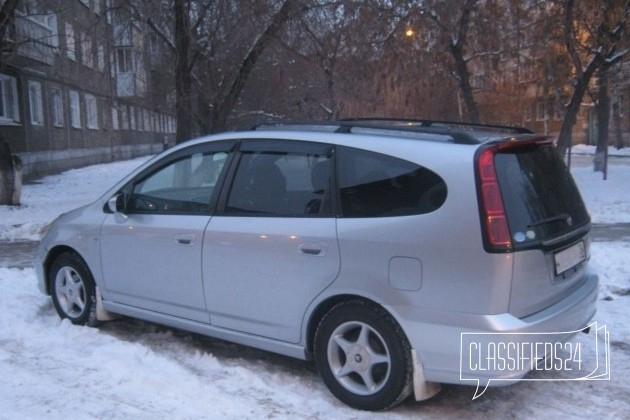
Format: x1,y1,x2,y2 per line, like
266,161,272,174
36,119,598,410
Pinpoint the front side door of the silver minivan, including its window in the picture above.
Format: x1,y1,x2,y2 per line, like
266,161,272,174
101,145,228,323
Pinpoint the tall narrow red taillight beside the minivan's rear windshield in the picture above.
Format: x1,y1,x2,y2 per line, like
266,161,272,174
477,146,512,252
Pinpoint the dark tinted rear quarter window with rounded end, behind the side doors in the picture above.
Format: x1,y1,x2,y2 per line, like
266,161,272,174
338,147,447,217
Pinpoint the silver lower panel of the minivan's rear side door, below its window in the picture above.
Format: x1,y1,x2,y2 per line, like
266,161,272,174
203,216,340,343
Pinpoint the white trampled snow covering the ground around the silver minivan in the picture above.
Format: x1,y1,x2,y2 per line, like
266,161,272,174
0,149,630,419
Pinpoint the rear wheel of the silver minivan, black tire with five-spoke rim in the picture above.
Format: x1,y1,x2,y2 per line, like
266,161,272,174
314,300,413,411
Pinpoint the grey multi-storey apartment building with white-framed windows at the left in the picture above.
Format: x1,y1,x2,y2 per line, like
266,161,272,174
0,0,176,178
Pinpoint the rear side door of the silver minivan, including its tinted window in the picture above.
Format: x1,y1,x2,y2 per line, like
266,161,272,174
203,140,339,343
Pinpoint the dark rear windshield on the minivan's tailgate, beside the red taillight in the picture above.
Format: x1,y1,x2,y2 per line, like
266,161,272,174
495,145,590,250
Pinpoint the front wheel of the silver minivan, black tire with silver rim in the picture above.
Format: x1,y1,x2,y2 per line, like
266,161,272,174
48,252,98,327
